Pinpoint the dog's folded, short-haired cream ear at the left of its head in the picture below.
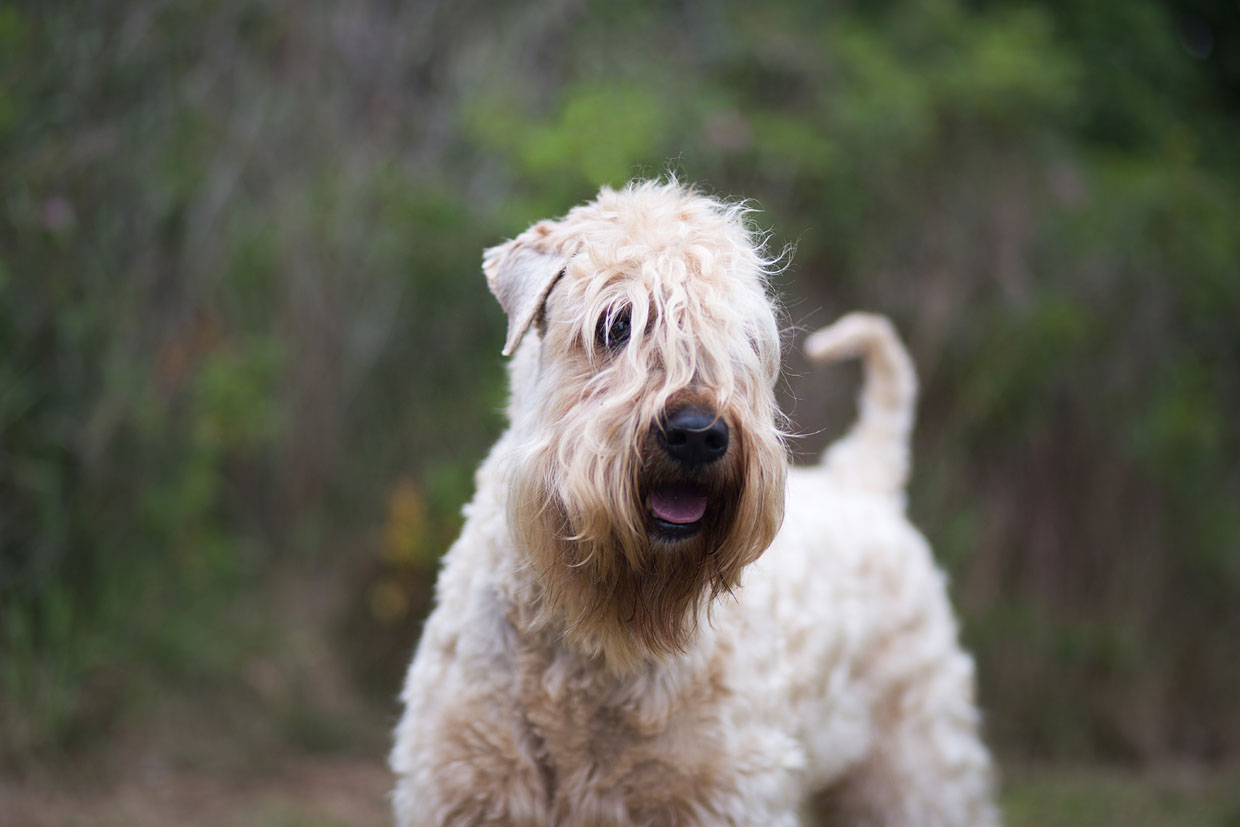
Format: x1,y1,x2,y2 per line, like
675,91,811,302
482,221,572,356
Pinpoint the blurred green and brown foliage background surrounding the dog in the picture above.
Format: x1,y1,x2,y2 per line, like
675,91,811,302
0,0,1240,826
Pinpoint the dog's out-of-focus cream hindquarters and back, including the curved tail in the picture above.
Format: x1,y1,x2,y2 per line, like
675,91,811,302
720,314,997,825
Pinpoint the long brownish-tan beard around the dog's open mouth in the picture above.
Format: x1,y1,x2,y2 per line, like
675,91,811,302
508,411,786,672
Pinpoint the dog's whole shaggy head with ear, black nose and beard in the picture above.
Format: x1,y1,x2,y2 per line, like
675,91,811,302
484,184,786,670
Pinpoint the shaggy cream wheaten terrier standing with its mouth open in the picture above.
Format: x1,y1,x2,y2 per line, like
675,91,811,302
392,181,997,827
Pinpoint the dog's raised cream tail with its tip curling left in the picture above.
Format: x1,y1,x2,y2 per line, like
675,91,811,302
805,312,918,496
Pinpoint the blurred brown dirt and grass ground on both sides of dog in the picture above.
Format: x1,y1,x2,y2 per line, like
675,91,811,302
0,755,1240,827
